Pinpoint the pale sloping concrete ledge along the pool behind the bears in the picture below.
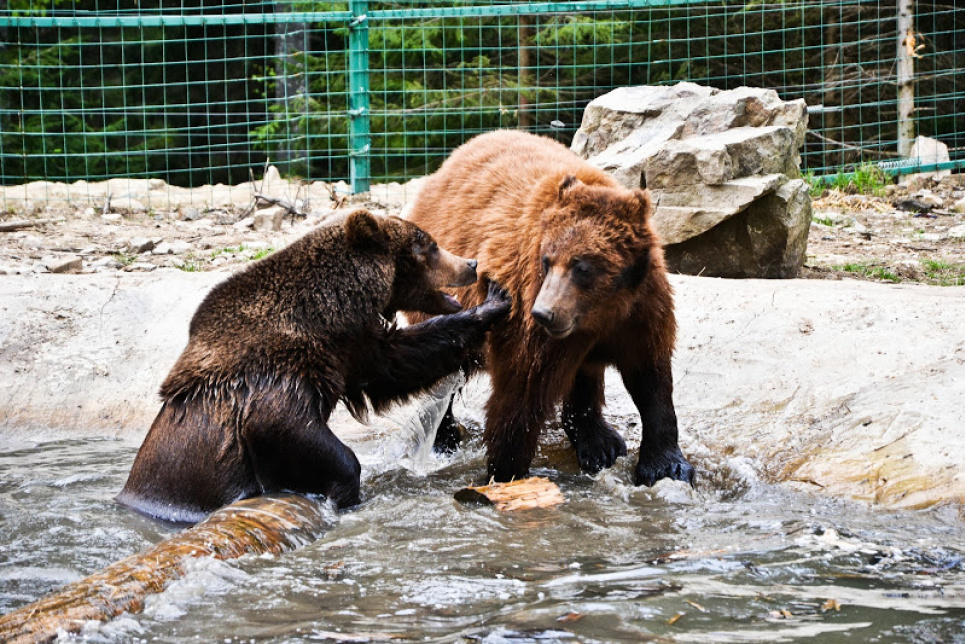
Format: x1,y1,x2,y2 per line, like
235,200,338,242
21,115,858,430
0,270,965,508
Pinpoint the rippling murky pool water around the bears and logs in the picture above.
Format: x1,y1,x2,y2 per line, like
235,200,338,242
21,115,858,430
0,430,965,642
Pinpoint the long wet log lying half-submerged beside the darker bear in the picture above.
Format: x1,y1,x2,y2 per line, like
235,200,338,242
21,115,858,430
0,494,331,644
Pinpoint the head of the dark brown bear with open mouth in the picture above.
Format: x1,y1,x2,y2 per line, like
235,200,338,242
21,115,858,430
344,210,477,319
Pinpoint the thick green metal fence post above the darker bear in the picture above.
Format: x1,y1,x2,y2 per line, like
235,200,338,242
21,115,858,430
348,0,372,194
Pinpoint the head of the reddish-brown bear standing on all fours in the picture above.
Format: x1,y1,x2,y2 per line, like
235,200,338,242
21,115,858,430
530,175,662,339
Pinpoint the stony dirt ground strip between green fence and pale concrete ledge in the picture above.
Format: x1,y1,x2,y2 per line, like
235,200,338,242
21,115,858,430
0,174,965,285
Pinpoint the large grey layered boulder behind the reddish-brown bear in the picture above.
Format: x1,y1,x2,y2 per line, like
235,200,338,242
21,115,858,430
571,83,811,277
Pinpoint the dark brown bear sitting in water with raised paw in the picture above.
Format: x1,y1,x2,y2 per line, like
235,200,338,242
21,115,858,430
117,211,510,522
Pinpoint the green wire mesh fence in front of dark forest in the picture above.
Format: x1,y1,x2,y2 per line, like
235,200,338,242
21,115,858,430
0,0,965,196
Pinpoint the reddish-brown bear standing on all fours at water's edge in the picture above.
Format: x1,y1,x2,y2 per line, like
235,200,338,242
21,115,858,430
409,130,694,485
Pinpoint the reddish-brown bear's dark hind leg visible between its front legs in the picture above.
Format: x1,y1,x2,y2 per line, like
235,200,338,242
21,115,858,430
561,365,627,474
